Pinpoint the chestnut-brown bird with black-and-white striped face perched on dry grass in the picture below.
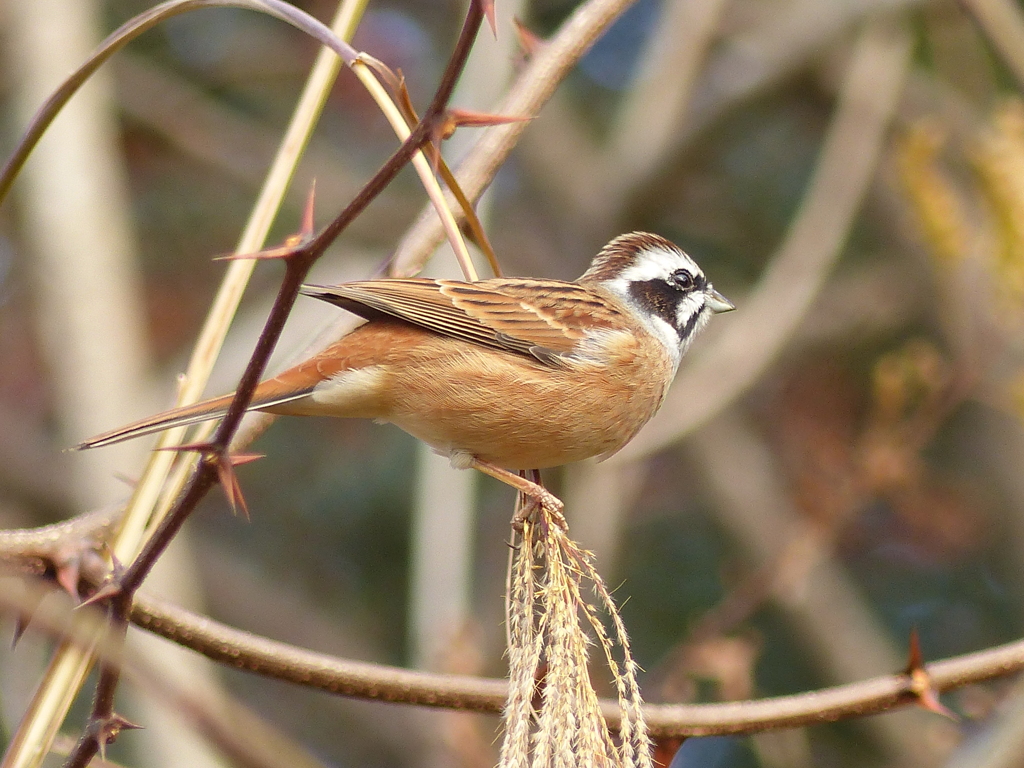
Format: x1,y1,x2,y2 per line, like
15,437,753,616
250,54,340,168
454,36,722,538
76,231,735,515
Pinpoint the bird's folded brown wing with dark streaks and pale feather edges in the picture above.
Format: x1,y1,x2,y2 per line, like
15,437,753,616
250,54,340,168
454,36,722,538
303,278,620,365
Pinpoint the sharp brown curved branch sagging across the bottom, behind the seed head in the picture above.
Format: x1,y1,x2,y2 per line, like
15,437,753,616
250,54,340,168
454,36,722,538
125,595,1024,736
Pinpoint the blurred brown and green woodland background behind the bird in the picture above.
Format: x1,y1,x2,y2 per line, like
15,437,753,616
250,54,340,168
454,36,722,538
0,0,1024,768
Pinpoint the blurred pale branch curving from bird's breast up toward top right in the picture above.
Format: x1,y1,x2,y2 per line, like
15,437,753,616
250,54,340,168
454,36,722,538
568,12,909,573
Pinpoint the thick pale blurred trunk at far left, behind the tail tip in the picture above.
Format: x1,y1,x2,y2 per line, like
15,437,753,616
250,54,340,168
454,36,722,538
9,0,227,768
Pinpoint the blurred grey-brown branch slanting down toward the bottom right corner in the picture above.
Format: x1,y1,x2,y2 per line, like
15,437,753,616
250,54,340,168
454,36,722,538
689,416,951,766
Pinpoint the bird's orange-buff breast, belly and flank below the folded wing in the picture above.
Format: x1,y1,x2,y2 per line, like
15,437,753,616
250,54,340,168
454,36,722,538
280,324,674,470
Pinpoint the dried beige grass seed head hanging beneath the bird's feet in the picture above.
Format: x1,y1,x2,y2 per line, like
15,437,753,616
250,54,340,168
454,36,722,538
501,515,651,768
